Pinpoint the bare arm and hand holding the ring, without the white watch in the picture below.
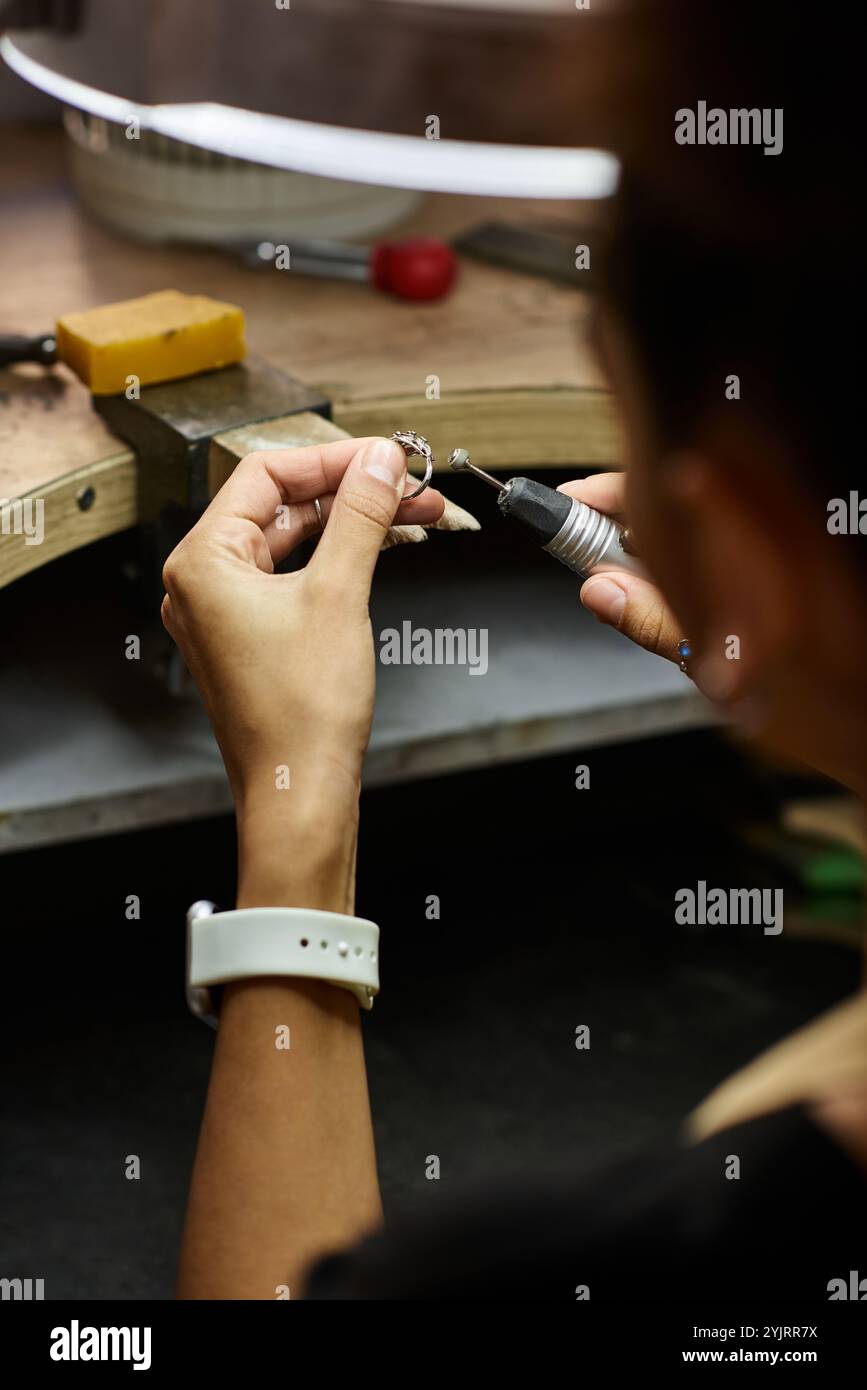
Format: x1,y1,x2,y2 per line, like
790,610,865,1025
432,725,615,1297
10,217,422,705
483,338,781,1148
161,439,419,1298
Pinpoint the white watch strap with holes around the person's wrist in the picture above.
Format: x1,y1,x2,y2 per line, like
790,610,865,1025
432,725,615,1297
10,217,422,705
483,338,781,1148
186,901,379,1026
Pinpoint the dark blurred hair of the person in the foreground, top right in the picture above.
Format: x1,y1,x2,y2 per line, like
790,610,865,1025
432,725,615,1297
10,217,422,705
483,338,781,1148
606,0,864,525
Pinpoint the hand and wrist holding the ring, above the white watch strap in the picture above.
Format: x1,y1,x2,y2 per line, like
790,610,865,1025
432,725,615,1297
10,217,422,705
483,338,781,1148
163,439,443,910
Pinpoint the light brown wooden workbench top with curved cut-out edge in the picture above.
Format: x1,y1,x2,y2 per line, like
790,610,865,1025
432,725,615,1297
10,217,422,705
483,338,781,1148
0,129,621,584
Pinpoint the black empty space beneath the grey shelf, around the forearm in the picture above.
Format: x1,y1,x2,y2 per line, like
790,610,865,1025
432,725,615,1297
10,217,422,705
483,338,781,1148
0,733,860,1298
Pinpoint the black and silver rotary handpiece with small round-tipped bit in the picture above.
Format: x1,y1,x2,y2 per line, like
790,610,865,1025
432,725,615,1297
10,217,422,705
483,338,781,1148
449,449,643,574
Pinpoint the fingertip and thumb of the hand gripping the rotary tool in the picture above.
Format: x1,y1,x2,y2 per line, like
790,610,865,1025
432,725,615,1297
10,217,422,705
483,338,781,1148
559,473,685,662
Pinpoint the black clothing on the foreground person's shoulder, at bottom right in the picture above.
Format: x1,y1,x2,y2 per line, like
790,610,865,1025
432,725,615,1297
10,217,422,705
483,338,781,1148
307,1108,867,1302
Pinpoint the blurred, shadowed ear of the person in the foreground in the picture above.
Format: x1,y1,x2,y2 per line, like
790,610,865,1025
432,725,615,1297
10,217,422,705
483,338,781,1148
666,438,806,701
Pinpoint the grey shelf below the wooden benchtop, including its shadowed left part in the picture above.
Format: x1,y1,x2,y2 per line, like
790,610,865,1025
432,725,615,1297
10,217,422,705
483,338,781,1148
0,535,710,851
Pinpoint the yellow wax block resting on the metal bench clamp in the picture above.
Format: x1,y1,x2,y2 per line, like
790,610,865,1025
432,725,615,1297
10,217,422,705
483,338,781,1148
57,289,246,396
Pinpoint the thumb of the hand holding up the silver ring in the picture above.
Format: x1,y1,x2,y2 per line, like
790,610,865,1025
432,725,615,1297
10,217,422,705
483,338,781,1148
308,439,406,596
